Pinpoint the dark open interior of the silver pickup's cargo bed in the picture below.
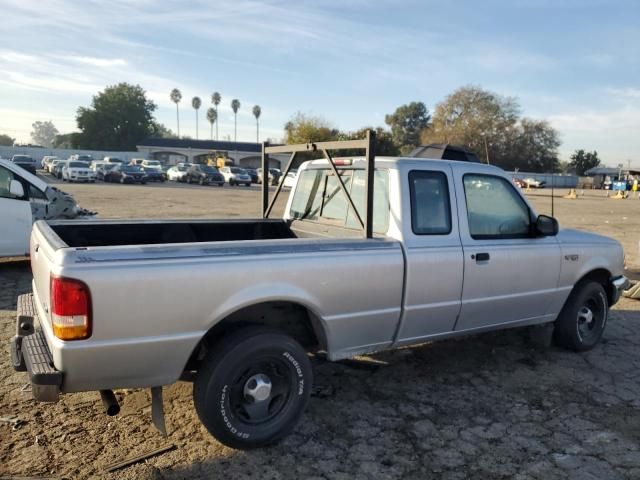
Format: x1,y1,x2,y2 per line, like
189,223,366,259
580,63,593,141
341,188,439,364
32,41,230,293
50,220,296,247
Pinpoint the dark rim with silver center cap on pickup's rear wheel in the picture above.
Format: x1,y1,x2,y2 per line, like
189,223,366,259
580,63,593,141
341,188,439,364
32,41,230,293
228,355,296,425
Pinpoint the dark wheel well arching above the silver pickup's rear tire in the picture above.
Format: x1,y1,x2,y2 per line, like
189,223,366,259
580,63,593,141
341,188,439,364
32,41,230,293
185,301,327,371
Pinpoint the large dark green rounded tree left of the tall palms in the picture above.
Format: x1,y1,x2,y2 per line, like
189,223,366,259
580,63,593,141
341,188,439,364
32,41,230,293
76,83,156,150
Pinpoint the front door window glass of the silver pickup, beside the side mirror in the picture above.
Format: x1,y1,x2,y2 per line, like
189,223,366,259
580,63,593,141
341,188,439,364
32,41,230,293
464,174,531,239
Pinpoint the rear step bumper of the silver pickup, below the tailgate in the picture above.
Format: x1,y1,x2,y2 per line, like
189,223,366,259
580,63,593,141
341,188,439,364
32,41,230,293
11,293,62,402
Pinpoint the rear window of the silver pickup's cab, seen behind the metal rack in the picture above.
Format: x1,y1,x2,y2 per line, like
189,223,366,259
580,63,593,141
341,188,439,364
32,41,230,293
289,169,389,234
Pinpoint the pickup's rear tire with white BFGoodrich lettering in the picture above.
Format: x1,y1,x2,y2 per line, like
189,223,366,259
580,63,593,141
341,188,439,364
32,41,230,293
193,327,313,450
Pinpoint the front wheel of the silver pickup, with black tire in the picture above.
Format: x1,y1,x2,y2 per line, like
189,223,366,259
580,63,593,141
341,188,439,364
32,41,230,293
553,281,609,352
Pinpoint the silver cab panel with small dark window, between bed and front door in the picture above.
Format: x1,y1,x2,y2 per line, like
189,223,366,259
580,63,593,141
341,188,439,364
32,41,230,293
396,161,463,345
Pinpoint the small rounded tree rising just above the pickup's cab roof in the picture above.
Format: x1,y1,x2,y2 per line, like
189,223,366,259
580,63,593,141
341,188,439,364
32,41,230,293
384,102,431,154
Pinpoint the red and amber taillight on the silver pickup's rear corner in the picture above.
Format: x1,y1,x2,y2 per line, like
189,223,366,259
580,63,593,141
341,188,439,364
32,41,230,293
51,277,91,340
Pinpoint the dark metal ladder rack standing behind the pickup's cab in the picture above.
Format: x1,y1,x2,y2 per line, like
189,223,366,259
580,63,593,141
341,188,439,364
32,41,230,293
262,130,376,238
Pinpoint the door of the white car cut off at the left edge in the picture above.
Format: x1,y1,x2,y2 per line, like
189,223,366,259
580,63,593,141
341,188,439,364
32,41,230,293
0,165,32,257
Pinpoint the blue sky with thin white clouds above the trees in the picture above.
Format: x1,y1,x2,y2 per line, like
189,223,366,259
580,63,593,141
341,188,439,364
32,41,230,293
0,0,640,166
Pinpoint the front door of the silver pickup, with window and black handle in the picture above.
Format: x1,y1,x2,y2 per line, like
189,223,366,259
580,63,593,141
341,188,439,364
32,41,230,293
454,165,560,330
